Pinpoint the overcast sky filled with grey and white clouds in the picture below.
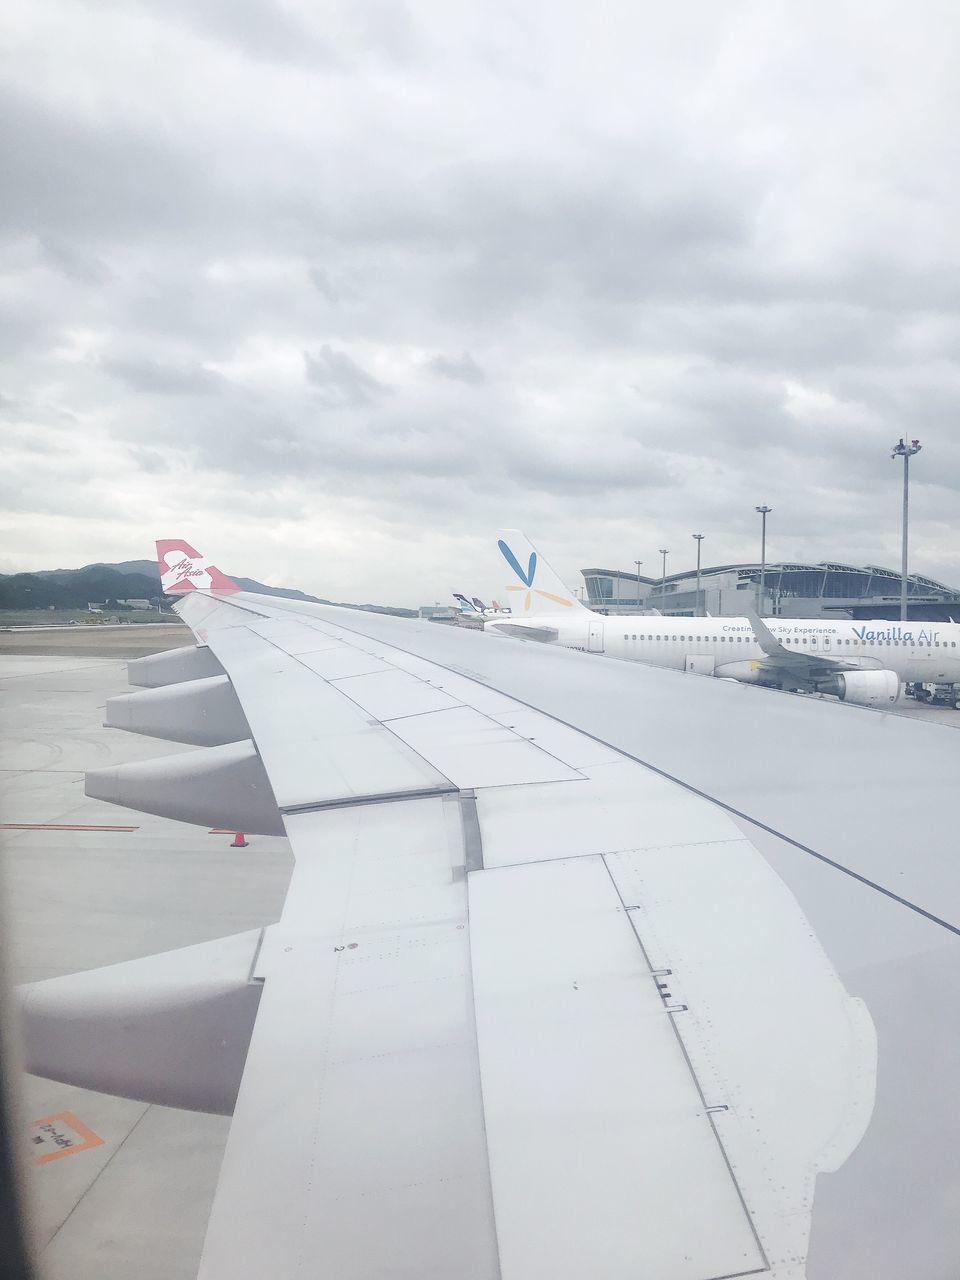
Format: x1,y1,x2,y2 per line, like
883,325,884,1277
0,0,960,605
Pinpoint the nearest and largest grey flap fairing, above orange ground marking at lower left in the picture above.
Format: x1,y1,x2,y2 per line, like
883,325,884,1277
18,929,262,1115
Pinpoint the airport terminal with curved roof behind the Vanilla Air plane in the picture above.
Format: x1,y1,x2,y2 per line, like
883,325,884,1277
581,563,960,622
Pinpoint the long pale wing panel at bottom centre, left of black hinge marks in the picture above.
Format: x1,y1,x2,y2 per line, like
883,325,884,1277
470,856,765,1280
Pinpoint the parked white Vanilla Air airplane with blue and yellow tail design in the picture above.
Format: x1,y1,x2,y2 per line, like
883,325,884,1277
484,529,960,705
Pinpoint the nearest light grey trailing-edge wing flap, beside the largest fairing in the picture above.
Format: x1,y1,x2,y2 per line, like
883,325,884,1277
193,797,498,1280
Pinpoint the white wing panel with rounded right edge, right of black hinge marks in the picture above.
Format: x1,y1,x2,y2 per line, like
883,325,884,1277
604,834,877,1257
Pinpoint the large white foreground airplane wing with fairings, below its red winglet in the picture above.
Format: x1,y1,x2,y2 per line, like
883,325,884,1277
16,550,960,1280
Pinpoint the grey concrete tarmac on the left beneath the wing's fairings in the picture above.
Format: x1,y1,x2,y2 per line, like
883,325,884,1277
0,660,292,1280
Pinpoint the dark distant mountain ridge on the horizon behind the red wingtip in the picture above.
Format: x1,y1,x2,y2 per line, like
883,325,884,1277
0,561,416,618
